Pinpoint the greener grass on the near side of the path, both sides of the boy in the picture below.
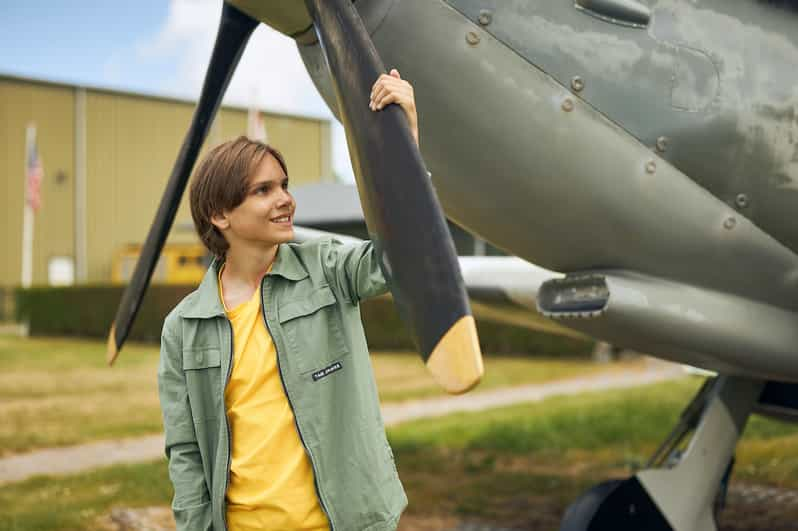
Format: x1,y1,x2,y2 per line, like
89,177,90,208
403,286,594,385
0,379,798,531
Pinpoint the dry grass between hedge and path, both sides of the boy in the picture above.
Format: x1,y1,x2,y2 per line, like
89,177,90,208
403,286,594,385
0,336,628,457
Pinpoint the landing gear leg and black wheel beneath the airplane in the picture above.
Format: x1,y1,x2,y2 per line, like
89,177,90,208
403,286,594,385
560,376,763,531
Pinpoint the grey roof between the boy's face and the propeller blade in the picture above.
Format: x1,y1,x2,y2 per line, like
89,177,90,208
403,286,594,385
291,183,365,225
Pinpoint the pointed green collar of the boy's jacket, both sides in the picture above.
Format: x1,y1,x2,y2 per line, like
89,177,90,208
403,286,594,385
180,243,308,319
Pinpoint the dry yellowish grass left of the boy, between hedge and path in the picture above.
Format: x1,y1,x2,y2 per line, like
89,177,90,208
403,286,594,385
0,336,161,456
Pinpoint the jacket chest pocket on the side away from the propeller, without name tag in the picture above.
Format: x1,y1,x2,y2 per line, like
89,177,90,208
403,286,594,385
183,347,222,422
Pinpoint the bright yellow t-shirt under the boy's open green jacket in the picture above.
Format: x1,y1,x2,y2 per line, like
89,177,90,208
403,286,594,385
219,271,329,531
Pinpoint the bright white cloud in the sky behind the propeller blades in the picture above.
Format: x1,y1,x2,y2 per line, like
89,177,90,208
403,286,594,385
136,0,354,180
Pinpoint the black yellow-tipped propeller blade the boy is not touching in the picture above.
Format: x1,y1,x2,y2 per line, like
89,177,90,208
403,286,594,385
107,2,259,365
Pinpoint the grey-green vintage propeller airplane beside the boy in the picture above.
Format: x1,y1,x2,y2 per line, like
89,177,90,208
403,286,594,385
109,0,798,531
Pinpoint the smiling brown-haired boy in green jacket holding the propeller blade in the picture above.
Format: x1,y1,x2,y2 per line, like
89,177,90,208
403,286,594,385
158,70,418,531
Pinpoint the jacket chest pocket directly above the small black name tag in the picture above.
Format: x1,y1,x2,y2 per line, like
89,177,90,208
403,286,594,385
278,286,349,373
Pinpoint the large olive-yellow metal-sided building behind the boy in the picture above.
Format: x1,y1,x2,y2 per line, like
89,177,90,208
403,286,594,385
0,76,334,287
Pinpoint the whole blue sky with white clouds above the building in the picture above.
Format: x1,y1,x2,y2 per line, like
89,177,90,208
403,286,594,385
0,0,354,181
